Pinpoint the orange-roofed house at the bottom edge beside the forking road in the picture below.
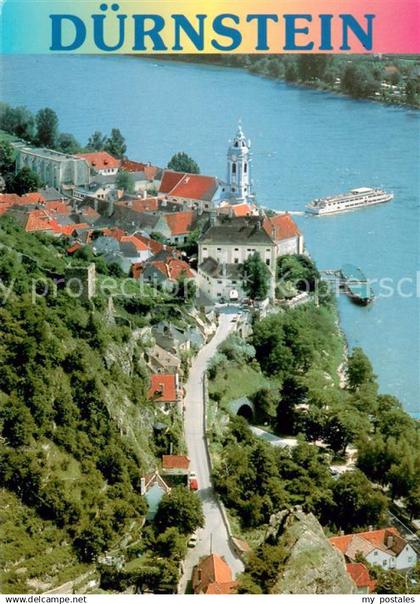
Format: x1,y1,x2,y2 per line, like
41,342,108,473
192,554,238,595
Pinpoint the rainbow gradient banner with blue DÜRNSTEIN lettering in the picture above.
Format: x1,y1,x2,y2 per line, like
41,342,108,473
0,0,420,54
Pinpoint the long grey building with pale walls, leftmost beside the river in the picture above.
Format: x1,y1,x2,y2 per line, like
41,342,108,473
15,145,90,189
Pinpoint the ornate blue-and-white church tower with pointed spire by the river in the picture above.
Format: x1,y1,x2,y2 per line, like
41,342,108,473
227,122,253,203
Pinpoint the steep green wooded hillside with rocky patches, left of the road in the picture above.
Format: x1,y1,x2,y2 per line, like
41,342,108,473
0,218,187,593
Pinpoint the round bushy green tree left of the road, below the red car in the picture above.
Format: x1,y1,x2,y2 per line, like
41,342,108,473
155,487,204,535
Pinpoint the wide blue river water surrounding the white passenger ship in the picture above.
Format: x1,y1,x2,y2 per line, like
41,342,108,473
0,56,420,414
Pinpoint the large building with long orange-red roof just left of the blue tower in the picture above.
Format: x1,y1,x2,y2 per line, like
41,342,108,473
159,170,221,210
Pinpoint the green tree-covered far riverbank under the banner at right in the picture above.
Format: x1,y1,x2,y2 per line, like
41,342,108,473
142,54,420,109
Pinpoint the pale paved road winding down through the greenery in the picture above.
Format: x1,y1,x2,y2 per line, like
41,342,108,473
180,314,244,592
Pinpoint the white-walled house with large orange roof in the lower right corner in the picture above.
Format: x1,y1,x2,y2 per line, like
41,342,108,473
329,527,417,570
